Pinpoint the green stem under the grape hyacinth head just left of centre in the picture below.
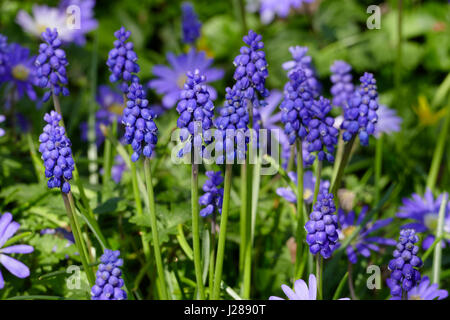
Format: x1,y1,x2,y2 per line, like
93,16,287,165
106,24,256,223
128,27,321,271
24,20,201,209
191,162,205,300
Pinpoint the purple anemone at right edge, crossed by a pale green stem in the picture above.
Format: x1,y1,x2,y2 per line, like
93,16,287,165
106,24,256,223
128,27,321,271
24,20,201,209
397,188,450,250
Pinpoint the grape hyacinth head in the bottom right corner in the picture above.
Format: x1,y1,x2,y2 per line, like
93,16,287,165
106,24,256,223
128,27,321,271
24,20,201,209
386,229,423,298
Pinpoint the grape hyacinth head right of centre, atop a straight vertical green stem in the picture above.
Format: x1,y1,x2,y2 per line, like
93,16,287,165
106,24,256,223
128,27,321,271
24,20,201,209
280,69,313,145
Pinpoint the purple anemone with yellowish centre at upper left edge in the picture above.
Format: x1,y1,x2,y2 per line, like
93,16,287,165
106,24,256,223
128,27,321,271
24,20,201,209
0,43,38,101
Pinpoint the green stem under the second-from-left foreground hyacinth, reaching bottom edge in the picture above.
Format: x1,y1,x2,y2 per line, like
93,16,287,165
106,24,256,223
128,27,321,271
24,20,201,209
144,158,167,300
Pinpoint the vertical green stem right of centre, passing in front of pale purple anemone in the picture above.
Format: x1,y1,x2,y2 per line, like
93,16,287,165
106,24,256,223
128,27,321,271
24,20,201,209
294,139,305,279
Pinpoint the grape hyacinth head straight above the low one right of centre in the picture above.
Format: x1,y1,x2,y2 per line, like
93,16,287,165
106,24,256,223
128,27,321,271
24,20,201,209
306,97,339,164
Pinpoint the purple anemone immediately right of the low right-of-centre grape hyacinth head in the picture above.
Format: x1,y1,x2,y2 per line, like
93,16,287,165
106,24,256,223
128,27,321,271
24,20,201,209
338,206,396,264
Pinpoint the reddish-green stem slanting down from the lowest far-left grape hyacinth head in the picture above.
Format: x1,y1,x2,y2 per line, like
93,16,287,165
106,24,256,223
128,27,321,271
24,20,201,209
61,192,95,287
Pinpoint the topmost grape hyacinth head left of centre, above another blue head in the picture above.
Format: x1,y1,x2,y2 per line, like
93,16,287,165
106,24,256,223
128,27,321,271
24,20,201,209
106,27,140,93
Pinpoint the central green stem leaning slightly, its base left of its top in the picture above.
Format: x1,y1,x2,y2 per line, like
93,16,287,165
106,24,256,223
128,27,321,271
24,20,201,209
213,164,233,300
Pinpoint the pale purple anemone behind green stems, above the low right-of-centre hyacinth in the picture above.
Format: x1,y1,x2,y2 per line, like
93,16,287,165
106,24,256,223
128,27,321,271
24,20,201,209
277,171,330,204
